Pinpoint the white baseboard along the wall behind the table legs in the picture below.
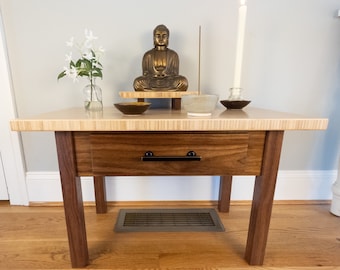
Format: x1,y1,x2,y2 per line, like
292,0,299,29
26,170,337,202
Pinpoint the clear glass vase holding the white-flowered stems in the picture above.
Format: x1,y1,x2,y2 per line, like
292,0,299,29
83,83,103,111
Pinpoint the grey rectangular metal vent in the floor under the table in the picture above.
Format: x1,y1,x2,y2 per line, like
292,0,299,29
115,208,224,232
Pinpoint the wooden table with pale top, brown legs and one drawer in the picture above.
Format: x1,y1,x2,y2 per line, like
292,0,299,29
11,108,328,267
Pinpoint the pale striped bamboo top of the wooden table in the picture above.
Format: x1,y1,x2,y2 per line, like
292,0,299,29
10,106,328,131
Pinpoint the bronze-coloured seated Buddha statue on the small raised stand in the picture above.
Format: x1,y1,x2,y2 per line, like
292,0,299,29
133,25,188,91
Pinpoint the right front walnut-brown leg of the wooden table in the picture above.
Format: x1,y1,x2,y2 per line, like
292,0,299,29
245,131,283,265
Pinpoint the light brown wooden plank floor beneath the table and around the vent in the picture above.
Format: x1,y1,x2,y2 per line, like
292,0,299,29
0,203,340,270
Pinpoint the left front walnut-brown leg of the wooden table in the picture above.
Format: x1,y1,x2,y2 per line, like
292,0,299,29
55,131,89,268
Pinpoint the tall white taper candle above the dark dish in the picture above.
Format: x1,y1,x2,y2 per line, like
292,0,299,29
233,0,247,88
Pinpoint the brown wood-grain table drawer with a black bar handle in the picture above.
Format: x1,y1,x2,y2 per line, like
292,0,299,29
85,132,265,176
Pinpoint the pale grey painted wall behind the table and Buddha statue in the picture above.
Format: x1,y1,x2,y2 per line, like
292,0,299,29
0,0,340,202
